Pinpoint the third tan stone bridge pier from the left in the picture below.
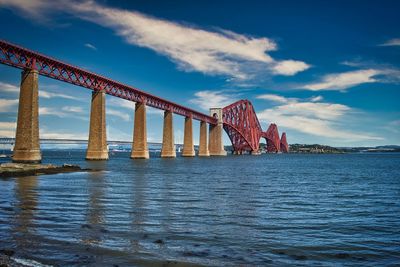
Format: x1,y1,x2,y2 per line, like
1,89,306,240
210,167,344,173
131,103,149,159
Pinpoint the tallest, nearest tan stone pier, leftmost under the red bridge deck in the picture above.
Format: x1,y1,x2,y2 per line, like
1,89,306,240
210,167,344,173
12,69,42,163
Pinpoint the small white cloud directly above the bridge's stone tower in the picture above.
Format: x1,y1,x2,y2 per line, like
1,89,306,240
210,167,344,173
189,91,238,111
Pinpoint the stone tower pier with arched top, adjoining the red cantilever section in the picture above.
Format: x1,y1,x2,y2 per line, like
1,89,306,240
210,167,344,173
208,108,226,156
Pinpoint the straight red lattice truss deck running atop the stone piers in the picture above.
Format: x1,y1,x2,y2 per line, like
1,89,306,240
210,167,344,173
0,40,217,125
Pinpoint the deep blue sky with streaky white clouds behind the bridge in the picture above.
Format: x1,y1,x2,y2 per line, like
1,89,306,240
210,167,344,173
0,0,400,146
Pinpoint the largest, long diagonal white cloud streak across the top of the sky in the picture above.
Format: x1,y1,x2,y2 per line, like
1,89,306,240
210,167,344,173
0,0,309,80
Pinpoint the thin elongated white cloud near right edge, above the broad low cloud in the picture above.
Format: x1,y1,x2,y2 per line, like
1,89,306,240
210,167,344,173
303,69,384,91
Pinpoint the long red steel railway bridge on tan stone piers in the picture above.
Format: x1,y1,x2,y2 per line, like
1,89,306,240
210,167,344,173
0,40,289,162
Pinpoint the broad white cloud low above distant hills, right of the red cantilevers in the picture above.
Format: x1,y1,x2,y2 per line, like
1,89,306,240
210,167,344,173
257,94,382,141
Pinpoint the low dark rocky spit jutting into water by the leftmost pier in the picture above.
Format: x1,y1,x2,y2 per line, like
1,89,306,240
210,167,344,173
0,163,93,177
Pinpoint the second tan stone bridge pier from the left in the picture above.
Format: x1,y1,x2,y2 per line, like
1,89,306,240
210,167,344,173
86,91,108,160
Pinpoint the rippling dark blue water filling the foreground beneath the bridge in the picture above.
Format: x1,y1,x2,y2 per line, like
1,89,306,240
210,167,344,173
0,151,400,266
